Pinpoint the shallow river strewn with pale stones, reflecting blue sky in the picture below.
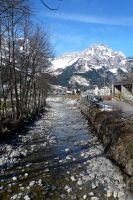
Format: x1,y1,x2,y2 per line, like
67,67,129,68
0,97,132,200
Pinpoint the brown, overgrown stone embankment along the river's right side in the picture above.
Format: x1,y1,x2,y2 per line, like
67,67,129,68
80,103,133,192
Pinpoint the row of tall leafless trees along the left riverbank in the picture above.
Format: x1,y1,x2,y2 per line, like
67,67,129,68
0,0,52,123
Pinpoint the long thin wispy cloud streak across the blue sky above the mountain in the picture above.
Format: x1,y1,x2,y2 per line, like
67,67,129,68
47,13,133,26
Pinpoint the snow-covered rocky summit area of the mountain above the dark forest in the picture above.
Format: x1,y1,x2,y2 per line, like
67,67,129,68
49,44,127,73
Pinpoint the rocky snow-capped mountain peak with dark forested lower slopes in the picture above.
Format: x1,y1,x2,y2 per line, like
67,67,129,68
48,44,129,87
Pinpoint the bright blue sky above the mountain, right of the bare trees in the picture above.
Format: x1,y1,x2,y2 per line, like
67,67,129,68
30,0,133,56
